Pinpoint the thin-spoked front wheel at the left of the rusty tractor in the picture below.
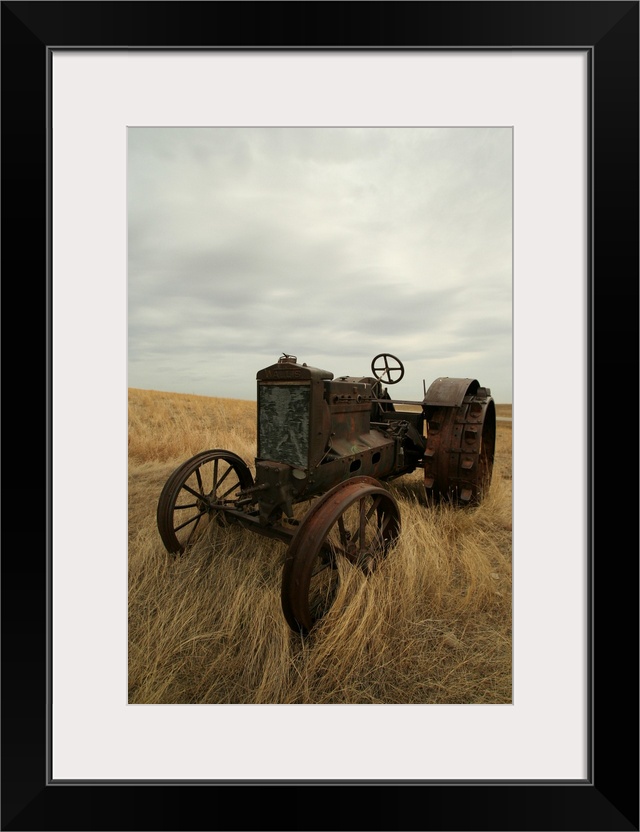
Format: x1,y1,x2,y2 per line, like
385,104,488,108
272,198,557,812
157,449,253,554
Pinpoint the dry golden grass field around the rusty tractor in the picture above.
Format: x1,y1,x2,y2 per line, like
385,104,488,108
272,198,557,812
129,389,512,705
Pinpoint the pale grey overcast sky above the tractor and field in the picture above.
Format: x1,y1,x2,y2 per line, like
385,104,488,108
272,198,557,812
128,127,512,402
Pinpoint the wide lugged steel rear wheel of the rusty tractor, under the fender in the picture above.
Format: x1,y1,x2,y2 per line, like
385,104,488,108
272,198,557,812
424,396,496,505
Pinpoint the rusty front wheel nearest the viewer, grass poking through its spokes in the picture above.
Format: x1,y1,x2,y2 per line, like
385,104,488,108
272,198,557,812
282,477,400,633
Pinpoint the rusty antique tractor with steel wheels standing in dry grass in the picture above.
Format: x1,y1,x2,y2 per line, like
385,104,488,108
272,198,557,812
157,353,496,634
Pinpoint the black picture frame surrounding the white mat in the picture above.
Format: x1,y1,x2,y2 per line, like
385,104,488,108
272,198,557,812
1,0,639,832
